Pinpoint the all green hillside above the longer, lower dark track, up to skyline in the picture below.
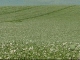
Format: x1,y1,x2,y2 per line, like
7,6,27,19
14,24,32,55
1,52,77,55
0,6,76,22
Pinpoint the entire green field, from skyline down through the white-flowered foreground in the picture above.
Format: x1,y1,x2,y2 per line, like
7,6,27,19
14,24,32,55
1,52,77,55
0,5,80,59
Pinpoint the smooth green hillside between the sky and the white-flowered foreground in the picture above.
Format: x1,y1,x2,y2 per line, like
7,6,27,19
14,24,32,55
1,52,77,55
0,6,80,42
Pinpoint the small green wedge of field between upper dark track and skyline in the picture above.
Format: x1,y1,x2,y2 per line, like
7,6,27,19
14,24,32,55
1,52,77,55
0,7,33,15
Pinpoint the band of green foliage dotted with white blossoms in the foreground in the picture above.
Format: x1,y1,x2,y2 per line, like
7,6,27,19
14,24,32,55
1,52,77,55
0,40,80,59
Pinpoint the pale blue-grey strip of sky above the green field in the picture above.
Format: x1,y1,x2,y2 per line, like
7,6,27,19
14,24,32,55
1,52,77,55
0,0,80,6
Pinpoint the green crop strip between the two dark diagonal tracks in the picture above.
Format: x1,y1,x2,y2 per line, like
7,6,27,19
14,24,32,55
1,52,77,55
0,6,74,22
